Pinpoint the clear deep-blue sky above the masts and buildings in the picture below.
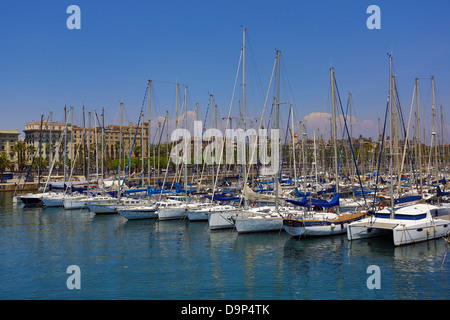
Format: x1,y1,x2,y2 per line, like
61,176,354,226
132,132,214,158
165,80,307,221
0,0,450,140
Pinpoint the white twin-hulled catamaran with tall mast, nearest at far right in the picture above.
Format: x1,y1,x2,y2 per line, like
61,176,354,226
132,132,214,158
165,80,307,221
347,55,450,246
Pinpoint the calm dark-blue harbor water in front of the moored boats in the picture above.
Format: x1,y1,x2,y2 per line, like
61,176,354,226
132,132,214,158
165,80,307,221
0,192,450,300
